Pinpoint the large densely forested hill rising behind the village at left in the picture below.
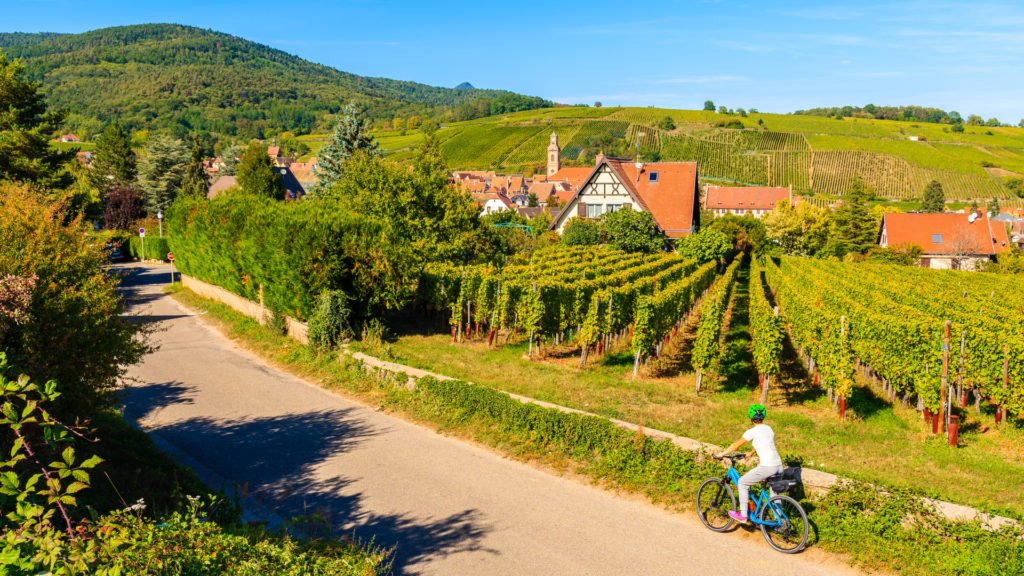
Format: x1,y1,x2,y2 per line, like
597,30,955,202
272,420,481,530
0,25,551,137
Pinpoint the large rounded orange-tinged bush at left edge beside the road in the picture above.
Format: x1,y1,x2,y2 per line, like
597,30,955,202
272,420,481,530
0,187,147,415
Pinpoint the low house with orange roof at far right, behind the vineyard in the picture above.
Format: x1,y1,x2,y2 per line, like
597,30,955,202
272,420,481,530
879,211,1011,270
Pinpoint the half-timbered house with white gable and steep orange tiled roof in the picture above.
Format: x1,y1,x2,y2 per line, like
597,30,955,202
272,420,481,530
551,155,700,238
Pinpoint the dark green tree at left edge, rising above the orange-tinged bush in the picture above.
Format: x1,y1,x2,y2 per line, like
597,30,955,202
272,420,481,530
0,51,76,188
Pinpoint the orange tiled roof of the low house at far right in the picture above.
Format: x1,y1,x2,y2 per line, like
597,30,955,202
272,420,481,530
882,212,1010,256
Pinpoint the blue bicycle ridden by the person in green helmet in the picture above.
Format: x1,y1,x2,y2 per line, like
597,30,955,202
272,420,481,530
696,453,810,554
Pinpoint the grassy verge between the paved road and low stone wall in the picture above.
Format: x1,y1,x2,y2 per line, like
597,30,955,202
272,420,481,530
174,282,1024,576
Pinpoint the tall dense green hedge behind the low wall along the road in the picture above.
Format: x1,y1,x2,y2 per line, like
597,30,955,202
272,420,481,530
165,194,372,320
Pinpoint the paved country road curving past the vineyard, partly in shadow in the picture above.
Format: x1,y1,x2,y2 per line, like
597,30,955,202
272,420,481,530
116,265,855,576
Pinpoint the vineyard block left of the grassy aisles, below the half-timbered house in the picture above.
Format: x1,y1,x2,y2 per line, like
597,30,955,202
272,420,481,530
423,246,716,365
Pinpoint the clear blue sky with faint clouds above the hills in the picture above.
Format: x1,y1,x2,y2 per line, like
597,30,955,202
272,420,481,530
8,0,1024,124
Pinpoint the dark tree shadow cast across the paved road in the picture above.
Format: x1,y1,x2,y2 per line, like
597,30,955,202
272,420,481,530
123,381,489,575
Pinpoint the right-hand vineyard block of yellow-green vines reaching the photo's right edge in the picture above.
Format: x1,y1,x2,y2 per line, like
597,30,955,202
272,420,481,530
751,257,1024,419
